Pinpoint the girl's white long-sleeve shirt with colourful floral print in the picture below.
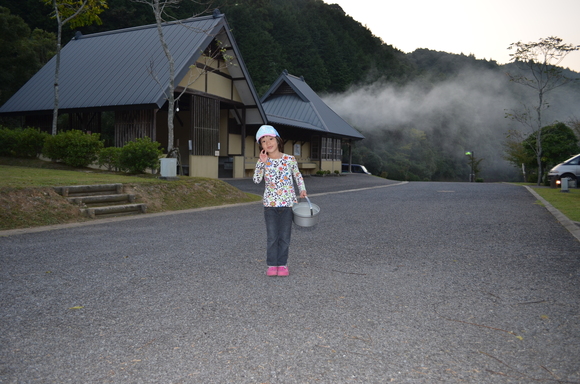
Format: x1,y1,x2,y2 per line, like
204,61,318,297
254,153,306,207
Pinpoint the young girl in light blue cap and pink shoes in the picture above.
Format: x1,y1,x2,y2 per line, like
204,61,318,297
254,125,306,276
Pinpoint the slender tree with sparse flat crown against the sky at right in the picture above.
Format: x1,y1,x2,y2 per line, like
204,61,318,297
508,36,580,185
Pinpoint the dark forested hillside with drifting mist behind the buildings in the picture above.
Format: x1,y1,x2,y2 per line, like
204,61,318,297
0,0,580,181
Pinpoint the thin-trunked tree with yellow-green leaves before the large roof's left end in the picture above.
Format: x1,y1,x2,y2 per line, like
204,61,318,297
41,0,107,135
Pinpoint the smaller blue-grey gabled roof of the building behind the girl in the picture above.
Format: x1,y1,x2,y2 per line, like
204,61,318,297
262,71,364,140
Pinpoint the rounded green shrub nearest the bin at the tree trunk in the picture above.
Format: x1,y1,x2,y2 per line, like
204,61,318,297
119,137,163,173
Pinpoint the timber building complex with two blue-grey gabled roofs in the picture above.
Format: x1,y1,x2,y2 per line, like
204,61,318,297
0,10,364,178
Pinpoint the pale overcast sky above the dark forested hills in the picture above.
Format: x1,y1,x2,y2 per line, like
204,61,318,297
324,0,580,72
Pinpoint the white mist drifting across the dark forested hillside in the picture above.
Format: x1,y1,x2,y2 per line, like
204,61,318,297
323,69,580,179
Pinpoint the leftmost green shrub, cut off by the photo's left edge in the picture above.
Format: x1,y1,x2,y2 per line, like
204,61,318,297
0,127,49,157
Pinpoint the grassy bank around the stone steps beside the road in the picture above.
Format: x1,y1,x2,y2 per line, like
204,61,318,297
0,158,261,230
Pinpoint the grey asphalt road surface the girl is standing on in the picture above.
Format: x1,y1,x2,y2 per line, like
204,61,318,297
0,175,580,383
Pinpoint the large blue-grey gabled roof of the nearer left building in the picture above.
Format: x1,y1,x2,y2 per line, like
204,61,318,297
0,11,265,124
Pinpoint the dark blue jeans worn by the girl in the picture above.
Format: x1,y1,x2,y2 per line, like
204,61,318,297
264,207,294,267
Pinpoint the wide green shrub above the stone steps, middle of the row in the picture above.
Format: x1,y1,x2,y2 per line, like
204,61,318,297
42,129,103,167
